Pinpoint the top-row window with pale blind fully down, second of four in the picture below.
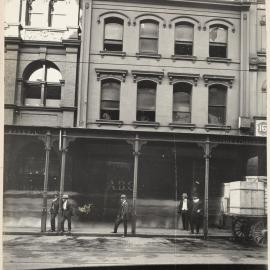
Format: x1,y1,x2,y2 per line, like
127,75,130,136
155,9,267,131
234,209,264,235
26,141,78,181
139,20,159,54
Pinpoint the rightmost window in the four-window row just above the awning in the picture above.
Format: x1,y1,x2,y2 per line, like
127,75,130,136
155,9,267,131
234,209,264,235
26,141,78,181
208,85,227,125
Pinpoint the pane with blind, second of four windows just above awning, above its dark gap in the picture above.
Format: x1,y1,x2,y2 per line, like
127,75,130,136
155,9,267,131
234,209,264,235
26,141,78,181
137,89,156,111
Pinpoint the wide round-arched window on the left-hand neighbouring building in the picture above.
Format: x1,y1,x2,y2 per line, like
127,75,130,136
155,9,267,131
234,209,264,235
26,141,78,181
23,61,62,107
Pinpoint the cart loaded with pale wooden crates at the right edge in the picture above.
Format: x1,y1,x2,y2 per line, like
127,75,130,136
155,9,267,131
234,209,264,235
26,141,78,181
223,177,267,247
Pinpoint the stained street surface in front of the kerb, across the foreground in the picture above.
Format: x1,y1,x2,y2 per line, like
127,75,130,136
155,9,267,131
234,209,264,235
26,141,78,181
3,234,267,270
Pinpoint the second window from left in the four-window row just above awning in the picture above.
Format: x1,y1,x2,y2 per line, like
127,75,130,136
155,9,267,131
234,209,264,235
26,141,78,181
137,81,157,122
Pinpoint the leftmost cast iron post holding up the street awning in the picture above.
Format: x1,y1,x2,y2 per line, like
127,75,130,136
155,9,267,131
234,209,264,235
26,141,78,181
41,131,51,232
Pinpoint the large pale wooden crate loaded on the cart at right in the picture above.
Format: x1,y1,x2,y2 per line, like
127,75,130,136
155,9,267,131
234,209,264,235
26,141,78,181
229,181,266,216
